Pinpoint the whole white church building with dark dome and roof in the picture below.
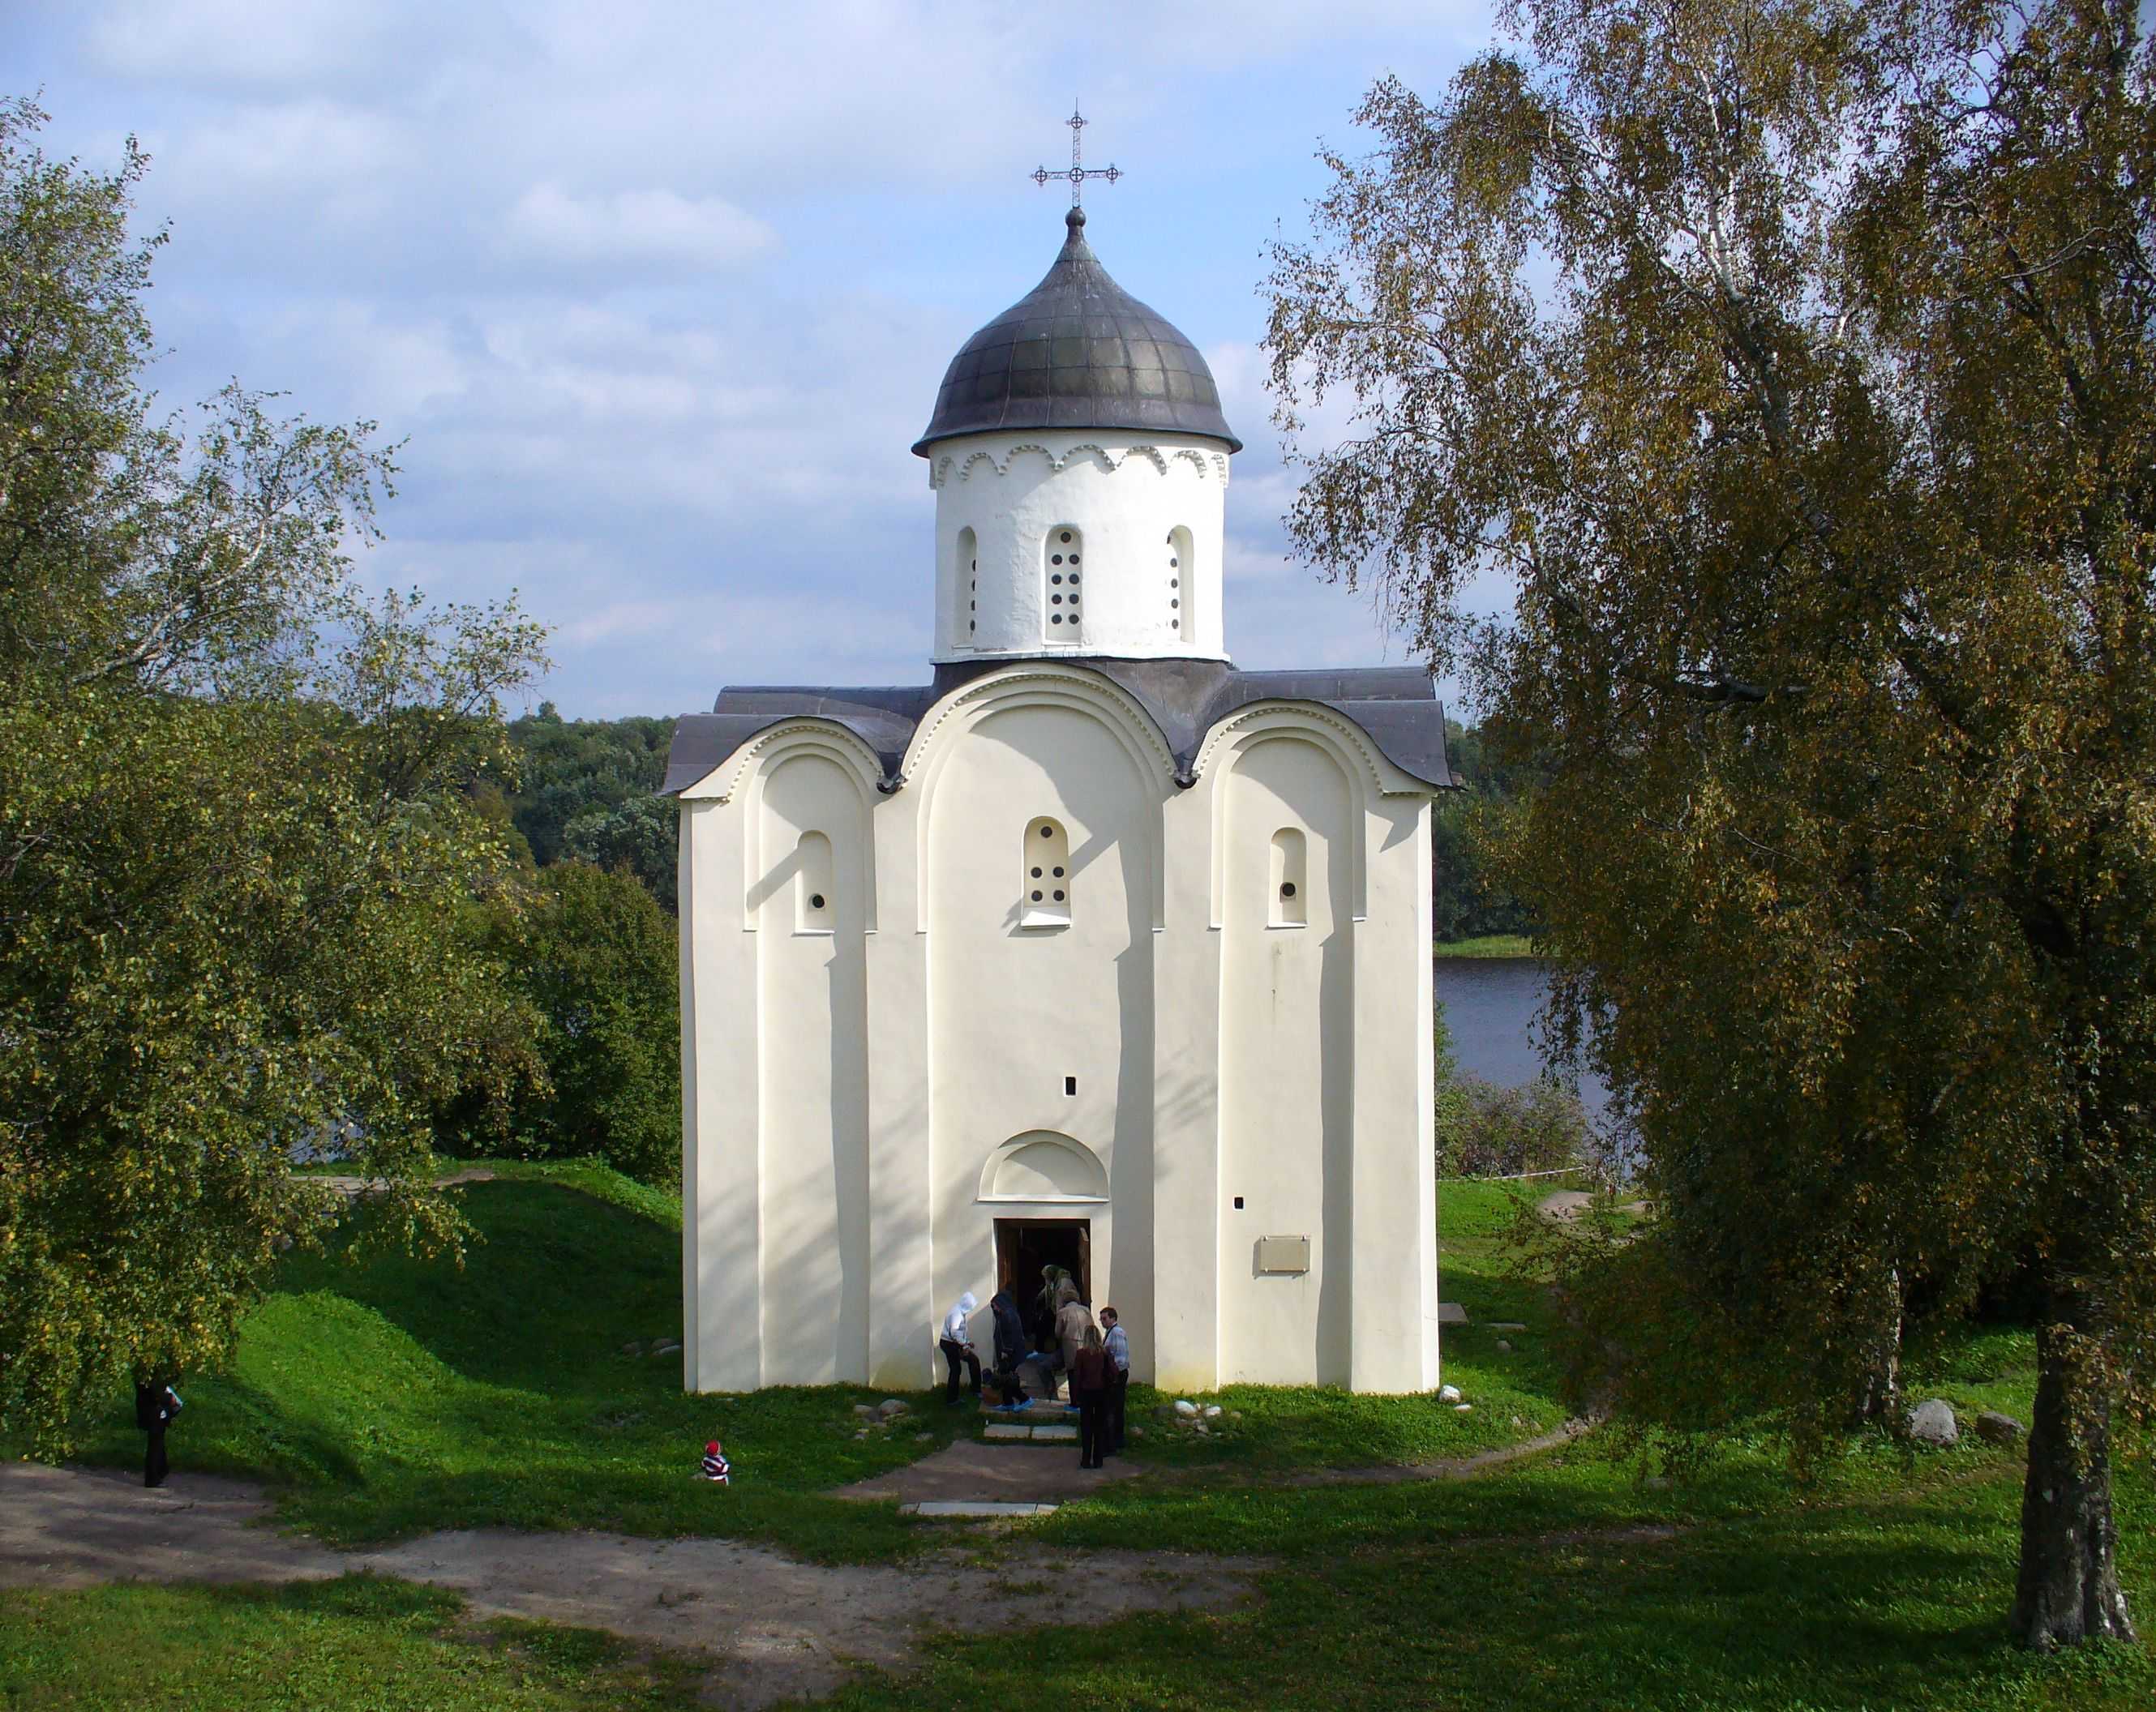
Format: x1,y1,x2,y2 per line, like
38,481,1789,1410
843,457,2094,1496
667,207,1449,1391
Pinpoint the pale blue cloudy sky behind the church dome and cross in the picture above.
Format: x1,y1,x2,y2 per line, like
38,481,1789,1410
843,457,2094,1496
12,0,1492,718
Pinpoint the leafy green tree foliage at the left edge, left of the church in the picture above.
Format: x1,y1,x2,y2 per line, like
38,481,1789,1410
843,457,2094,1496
0,104,539,1449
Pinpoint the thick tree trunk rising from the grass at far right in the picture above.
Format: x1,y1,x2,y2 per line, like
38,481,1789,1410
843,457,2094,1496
2012,1326,2134,1652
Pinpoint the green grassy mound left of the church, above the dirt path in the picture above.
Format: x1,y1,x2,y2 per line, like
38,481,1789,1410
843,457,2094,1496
62,1166,971,1559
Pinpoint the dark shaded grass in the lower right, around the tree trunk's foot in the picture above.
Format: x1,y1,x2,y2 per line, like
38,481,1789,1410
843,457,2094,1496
834,1481,2156,1712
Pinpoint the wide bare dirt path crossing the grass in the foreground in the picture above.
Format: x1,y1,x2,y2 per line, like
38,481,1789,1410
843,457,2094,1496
0,1457,1263,1706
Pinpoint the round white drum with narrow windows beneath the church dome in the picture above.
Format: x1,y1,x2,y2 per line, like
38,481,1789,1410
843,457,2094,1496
929,431,1229,662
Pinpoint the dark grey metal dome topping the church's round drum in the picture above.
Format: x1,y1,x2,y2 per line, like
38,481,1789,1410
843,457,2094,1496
914,209,1242,457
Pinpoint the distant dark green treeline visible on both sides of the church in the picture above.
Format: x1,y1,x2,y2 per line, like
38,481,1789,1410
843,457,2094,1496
498,700,1535,940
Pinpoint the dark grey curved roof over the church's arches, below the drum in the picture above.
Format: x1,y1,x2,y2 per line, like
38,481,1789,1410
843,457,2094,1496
660,657,1453,796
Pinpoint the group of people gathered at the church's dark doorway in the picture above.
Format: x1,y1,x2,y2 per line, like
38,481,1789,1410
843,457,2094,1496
938,1265,1129,1468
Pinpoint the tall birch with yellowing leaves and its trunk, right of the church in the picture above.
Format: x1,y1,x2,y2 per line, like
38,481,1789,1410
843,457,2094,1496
1270,0,2156,1646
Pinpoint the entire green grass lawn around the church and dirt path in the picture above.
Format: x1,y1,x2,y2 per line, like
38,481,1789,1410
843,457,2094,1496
0,1166,2156,1712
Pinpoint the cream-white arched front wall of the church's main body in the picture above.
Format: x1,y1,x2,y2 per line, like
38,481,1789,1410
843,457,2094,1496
681,662,1436,1391
